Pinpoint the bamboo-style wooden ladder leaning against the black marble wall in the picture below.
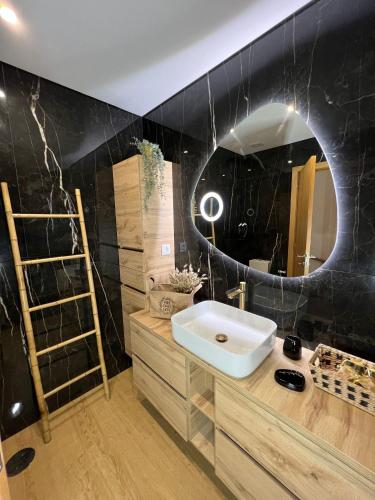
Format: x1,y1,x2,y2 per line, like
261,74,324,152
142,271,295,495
1,182,109,443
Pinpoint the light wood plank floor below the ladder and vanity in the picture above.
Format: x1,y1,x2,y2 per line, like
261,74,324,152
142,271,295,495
4,370,232,500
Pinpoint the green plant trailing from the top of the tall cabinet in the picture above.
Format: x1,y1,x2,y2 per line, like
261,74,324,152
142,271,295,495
132,137,165,211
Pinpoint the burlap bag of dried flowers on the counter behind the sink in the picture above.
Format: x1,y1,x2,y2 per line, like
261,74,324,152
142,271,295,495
150,265,207,319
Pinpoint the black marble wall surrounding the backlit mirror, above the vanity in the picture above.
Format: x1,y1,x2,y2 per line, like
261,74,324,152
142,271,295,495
144,0,375,359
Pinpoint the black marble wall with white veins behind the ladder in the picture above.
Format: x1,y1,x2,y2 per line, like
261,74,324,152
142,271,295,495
0,63,142,438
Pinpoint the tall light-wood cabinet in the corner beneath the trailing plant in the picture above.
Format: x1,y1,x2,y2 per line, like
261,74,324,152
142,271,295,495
113,155,175,355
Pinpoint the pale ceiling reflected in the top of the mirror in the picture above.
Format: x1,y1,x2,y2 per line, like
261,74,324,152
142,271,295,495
220,103,314,155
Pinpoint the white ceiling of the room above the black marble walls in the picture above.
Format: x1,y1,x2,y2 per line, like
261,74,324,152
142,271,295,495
0,0,309,115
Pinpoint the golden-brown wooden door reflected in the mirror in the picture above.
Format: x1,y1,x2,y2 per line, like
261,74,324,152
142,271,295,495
288,156,316,276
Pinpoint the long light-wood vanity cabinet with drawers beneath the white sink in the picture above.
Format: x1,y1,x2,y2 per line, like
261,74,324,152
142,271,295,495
130,311,375,500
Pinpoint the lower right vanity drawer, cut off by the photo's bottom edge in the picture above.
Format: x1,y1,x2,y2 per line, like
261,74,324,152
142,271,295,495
215,430,295,500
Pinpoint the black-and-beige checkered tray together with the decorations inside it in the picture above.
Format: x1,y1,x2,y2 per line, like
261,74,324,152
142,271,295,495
309,344,375,415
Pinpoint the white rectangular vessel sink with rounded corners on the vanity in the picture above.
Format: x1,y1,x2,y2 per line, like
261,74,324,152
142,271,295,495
172,300,277,378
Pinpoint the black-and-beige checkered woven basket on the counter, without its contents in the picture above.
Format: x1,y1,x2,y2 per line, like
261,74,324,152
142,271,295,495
309,344,375,415
